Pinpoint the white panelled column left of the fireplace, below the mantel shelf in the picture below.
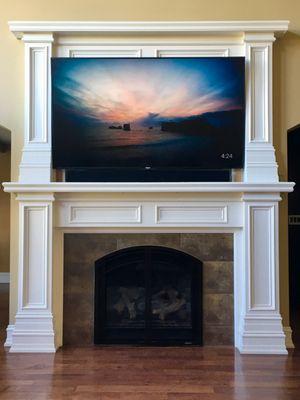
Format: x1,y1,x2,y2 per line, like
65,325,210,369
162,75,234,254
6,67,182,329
10,193,55,353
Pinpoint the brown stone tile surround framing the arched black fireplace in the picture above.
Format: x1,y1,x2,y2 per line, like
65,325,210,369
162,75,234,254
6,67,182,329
63,233,234,345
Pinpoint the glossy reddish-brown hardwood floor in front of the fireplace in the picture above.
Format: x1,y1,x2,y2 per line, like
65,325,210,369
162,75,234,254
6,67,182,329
0,284,300,400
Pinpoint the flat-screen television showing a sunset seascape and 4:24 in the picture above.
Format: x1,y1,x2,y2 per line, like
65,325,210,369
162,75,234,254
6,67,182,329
52,57,245,171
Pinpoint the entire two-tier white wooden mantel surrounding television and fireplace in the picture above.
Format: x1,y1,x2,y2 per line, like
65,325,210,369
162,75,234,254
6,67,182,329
4,21,293,354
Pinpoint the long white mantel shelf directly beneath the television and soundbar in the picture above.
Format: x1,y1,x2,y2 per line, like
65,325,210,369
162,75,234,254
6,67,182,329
3,182,295,193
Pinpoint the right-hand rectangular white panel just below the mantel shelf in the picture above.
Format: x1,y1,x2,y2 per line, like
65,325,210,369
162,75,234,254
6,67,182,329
155,205,228,225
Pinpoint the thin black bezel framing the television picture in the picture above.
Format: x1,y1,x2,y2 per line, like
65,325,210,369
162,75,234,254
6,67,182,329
51,56,246,177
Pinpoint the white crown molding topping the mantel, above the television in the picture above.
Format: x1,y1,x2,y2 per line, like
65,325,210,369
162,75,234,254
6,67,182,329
8,20,289,39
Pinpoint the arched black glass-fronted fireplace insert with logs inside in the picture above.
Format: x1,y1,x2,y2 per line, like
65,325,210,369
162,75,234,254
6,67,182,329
94,246,202,345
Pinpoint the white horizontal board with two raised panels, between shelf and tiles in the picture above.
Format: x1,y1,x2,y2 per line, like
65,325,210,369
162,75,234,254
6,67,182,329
54,199,243,229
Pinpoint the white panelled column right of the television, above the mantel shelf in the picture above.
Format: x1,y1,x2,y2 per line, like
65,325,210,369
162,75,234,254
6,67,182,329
244,33,278,183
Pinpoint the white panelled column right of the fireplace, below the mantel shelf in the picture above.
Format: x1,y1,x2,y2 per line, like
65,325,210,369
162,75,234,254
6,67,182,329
235,193,287,354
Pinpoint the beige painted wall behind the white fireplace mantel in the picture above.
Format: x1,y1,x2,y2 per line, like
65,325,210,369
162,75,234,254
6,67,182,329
0,0,300,325
